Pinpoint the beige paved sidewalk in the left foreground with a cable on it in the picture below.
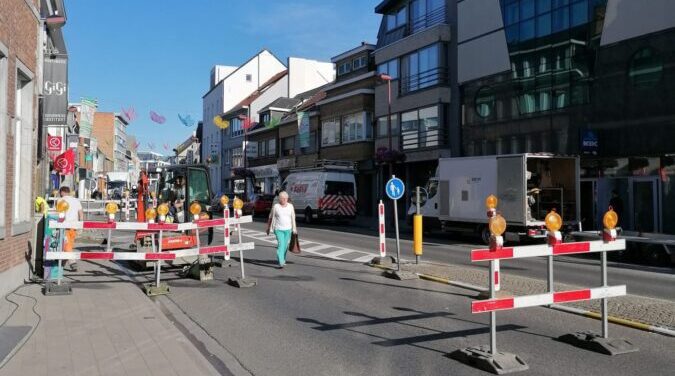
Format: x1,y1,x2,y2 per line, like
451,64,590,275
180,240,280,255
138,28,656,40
0,262,218,376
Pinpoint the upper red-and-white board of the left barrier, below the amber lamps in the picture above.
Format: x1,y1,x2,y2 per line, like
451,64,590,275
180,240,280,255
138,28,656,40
49,215,253,231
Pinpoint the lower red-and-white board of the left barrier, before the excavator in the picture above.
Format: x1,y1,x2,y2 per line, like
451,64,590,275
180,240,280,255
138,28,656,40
45,242,255,261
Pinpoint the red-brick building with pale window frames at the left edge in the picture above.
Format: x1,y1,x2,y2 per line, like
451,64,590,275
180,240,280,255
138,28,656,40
0,0,42,295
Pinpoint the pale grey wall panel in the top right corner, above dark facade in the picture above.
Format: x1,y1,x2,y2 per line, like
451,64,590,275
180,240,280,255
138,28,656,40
600,0,675,46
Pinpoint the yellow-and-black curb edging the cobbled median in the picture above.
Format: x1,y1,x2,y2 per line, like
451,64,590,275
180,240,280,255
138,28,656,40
368,264,675,337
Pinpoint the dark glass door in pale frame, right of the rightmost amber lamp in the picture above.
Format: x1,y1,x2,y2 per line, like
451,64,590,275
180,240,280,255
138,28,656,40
632,177,659,232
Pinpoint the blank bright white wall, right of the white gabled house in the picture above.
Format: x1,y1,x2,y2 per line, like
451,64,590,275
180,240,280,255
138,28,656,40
288,57,335,98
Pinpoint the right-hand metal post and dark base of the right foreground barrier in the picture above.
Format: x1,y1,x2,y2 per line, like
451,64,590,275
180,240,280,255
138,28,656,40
558,252,639,355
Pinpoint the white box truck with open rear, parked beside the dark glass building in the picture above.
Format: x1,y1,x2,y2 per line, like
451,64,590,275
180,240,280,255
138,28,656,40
408,153,580,243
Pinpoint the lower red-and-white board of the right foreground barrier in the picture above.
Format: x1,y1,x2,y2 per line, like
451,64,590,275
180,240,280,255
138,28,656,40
471,285,626,313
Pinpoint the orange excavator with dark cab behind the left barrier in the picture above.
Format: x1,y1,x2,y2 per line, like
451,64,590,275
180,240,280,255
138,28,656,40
135,164,213,266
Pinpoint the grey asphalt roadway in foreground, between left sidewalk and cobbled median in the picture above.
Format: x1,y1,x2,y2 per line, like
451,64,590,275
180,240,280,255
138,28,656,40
140,238,675,376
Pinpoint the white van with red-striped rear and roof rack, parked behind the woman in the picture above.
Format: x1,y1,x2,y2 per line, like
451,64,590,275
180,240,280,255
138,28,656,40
281,167,357,223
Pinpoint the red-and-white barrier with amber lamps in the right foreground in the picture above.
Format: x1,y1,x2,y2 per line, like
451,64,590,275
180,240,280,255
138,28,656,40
450,196,638,374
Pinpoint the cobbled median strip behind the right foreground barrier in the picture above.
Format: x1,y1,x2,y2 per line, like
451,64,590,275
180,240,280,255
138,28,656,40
386,262,675,329
